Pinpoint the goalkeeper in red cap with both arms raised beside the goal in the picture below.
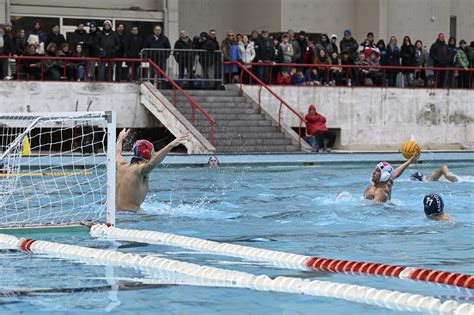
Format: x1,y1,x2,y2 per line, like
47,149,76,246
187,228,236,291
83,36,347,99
115,129,191,212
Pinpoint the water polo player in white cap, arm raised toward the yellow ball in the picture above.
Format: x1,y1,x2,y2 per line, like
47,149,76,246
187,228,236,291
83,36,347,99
364,154,418,203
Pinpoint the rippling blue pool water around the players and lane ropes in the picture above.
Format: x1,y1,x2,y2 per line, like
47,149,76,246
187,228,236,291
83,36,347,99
0,162,474,314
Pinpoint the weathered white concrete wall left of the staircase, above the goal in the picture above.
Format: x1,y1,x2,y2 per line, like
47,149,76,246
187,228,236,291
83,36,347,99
0,81,161,128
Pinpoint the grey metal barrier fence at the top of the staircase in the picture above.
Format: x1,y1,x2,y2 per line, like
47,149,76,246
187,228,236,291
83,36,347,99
140,48,224,90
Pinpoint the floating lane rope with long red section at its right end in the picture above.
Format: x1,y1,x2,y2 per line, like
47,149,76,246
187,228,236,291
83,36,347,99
90,224,474,289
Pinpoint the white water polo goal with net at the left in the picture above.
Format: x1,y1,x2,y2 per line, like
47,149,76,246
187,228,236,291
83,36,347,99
0,112,116,229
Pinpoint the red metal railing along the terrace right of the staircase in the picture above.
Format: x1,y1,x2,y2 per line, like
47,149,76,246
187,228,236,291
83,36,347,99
237,62,474,89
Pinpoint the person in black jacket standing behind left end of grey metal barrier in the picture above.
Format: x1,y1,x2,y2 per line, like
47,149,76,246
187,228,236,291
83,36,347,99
145,25,171,82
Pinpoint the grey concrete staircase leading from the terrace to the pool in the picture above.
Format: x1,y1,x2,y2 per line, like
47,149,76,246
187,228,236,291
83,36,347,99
160,90,304,153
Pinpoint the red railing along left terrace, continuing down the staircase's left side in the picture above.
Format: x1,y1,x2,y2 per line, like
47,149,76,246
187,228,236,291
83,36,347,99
0,56,217,145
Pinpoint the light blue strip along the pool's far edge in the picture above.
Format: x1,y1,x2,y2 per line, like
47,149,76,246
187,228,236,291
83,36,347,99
16,150,474,168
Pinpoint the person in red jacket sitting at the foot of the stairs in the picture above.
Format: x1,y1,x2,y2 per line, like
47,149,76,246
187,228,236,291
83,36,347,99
305,104,336,152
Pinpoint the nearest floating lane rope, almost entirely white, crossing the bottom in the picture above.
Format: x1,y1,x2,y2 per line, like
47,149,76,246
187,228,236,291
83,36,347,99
0,234,474,314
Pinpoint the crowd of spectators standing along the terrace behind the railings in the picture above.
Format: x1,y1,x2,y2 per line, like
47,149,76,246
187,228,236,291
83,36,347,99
0,21,474,88
